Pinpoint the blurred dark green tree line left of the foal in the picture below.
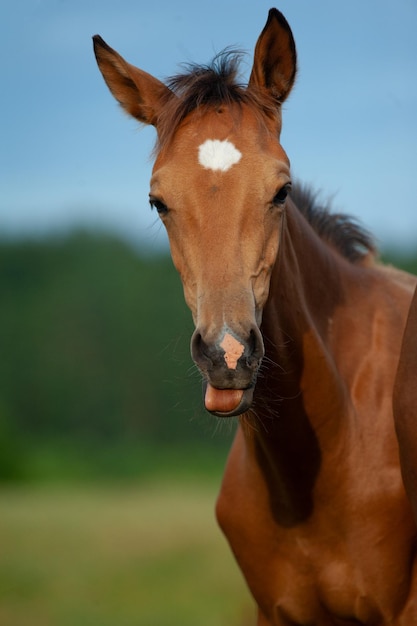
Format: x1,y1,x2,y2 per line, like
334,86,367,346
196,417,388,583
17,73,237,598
0,232,214,448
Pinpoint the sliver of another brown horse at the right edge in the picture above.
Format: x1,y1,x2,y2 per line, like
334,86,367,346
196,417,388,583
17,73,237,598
394,291,417,523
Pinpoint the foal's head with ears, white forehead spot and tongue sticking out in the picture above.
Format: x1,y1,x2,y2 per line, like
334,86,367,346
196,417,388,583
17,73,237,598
94,9,296,416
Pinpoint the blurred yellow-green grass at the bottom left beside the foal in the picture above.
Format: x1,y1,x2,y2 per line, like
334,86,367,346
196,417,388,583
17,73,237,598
0,479,254,626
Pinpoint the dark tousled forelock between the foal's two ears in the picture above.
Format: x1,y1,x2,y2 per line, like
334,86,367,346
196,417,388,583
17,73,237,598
157,48,278,150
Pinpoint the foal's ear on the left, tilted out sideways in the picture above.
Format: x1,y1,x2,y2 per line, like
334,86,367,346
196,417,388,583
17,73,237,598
93,35,172,126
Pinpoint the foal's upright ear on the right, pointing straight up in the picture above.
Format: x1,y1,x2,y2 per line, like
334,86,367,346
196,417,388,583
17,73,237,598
249,9,297,103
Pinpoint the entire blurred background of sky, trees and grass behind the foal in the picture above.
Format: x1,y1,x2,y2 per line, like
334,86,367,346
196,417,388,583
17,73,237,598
0,0,417,626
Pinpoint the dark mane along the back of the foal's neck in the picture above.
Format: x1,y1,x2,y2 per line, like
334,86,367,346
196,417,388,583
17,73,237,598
291,183,376,263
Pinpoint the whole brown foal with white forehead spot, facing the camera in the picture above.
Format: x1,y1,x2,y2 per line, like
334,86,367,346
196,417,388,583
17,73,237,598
94,9,417,626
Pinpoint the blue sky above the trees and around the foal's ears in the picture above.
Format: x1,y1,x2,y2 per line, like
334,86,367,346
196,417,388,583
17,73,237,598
0,0,417,248
